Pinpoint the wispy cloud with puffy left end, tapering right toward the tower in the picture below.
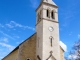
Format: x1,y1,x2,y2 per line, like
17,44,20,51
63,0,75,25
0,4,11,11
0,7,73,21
6,21,35,31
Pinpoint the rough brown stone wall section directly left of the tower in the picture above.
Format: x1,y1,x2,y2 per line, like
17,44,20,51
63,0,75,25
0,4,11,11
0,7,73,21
18,34,36,60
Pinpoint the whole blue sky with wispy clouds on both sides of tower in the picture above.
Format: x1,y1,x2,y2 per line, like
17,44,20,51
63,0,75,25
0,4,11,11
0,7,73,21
0,0,80,60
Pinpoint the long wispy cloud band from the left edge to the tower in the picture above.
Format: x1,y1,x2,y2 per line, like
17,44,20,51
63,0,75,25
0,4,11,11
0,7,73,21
0,21,35,31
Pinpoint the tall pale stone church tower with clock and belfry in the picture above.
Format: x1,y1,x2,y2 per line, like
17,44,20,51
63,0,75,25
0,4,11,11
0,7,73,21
36,0,60,60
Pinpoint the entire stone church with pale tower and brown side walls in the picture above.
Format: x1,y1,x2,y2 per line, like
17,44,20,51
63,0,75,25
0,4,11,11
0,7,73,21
2,0,65,60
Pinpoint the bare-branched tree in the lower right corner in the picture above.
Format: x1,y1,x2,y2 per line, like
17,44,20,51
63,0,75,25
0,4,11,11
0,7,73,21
65,40,80,60
